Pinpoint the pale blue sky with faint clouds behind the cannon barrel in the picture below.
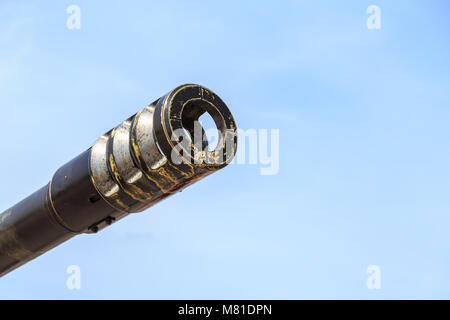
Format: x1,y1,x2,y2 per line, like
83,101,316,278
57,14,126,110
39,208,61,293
0,0,450,299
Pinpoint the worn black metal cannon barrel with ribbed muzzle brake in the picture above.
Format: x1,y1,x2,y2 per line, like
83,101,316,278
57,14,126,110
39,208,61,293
0,84,237,277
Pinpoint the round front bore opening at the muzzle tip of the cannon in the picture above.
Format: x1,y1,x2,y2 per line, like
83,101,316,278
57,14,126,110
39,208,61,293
181,100,224,151
